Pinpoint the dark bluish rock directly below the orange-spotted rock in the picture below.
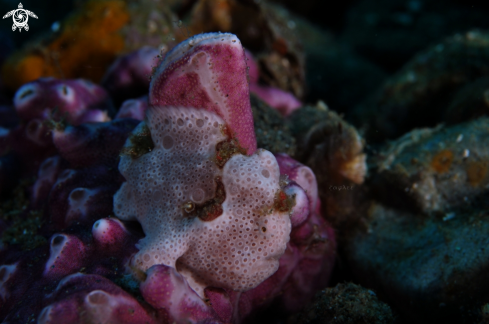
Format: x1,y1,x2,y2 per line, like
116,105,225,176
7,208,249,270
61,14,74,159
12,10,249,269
344,201,489,323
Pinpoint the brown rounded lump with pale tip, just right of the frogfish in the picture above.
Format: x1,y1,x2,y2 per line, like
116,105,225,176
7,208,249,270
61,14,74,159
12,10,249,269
289,102,367,226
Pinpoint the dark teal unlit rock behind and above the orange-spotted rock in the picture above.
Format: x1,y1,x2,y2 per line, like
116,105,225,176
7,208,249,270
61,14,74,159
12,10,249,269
355,30,489,142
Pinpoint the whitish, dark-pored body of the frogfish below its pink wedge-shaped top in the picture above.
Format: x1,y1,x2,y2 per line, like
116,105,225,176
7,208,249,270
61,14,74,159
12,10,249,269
114,107,291,297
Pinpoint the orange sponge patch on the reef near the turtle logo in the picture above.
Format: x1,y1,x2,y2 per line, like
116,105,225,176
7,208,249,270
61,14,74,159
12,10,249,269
2,0,129,90
